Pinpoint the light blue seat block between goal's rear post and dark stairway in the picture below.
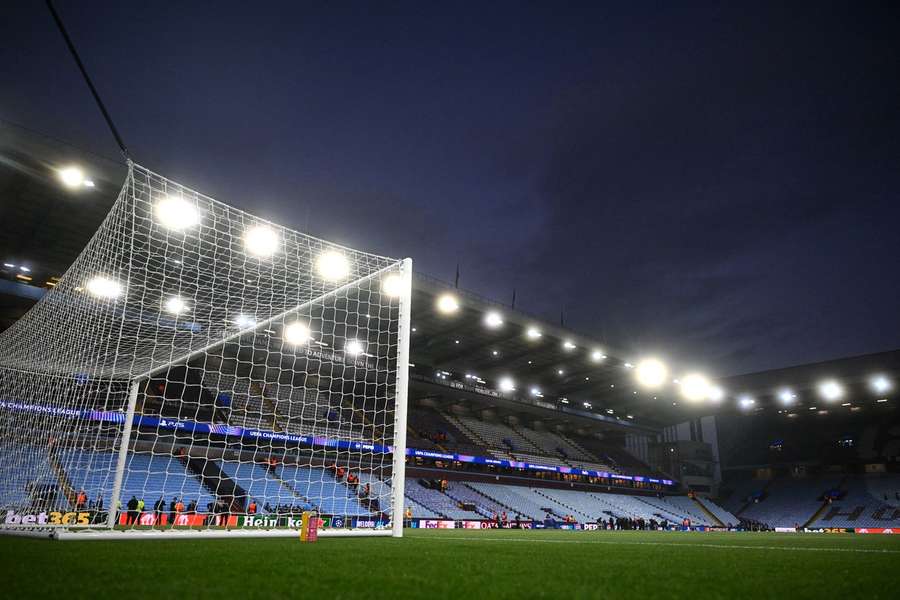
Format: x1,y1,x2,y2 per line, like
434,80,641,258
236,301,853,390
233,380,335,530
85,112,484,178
118,452,216,511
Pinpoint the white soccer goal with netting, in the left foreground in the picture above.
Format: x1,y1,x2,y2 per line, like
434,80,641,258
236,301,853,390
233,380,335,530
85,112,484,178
0,163,412,539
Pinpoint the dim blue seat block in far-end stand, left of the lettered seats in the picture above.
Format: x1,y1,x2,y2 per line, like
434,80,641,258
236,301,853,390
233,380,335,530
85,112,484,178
741,477,840,527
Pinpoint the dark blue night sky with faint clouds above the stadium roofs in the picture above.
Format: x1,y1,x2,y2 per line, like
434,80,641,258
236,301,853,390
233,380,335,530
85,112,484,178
0,0,900,375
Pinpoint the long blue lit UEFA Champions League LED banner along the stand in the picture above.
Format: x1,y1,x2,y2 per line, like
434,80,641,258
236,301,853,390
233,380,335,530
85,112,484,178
0,400,675,486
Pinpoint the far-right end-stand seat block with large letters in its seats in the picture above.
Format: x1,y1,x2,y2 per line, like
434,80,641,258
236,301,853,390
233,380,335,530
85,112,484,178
811,475,900,527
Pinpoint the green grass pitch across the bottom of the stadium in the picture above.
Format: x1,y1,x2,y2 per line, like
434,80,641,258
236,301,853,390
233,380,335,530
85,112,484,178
0,530,900,600
